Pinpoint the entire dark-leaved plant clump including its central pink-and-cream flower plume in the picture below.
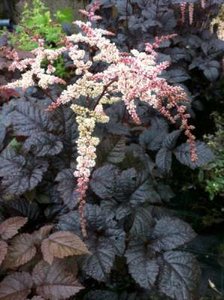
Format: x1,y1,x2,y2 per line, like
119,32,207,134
0,0,221,300
